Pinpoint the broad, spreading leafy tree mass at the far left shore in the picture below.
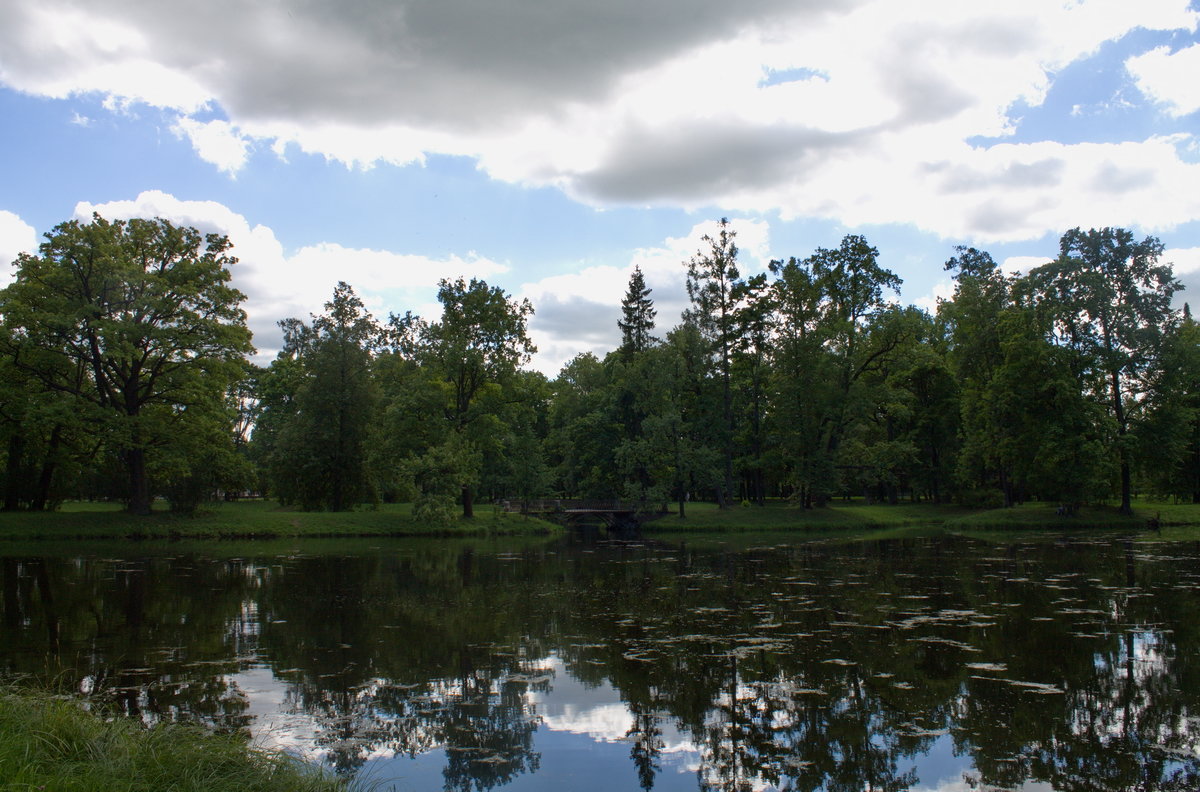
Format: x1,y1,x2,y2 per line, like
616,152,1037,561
0,216,252,514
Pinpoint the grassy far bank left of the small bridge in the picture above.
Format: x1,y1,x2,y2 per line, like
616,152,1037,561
0,500,557,540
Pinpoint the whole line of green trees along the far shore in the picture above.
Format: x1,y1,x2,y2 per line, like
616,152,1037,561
0,216,1200,521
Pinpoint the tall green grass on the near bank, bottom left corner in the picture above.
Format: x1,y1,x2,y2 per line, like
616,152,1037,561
0,688,347,792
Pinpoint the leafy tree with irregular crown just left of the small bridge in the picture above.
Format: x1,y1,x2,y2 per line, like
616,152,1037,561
420,278,538,517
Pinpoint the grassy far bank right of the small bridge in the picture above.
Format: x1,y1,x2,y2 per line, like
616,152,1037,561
647,499,1200,533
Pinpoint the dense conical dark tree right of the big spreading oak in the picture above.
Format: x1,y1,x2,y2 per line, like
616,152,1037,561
272,282,383,511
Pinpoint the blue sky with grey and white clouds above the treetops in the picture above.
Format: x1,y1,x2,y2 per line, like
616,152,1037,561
0,0,1200,376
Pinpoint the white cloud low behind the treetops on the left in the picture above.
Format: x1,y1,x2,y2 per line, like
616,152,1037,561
73,191,508,358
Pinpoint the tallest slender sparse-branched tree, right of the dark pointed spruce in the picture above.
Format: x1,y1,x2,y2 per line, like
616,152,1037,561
688,217,742,509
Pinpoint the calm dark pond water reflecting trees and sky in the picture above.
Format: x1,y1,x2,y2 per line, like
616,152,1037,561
0,535,1200,792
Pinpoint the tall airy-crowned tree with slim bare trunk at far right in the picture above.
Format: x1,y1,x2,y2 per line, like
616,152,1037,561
1030,228,1182,514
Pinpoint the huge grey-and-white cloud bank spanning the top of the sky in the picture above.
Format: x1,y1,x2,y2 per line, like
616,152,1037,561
0,0,1200,242
